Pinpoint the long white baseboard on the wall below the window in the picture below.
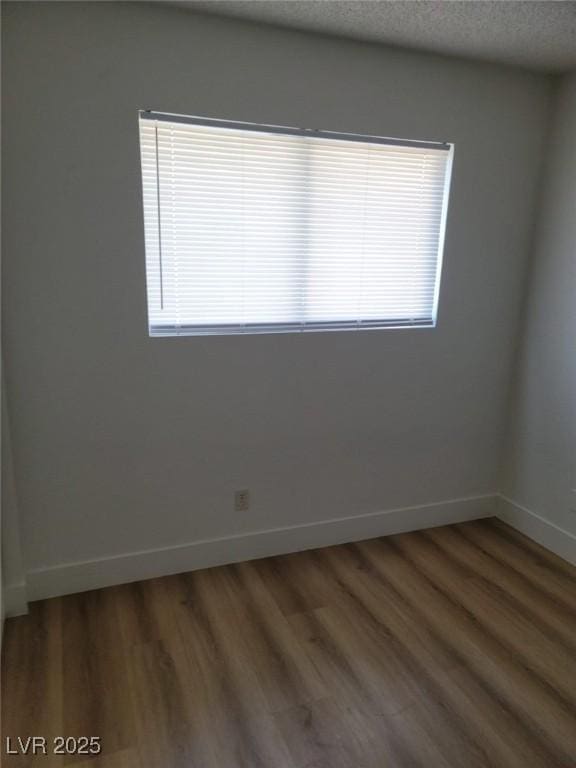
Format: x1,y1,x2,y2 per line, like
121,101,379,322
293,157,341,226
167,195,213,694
27,494,496,600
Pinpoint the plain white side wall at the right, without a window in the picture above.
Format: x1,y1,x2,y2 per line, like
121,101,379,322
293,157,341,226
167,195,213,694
503,73,576,558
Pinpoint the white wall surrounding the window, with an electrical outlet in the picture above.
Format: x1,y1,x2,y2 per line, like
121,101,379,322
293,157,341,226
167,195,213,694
3,2,549,588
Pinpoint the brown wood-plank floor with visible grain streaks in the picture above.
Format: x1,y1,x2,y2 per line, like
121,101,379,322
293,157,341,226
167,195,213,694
2,520,576,768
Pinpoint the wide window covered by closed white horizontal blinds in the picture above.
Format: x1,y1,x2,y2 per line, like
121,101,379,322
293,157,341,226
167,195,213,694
140,112,452,336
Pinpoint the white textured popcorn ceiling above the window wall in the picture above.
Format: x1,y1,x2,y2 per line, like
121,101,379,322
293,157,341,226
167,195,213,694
176,0,576,72
